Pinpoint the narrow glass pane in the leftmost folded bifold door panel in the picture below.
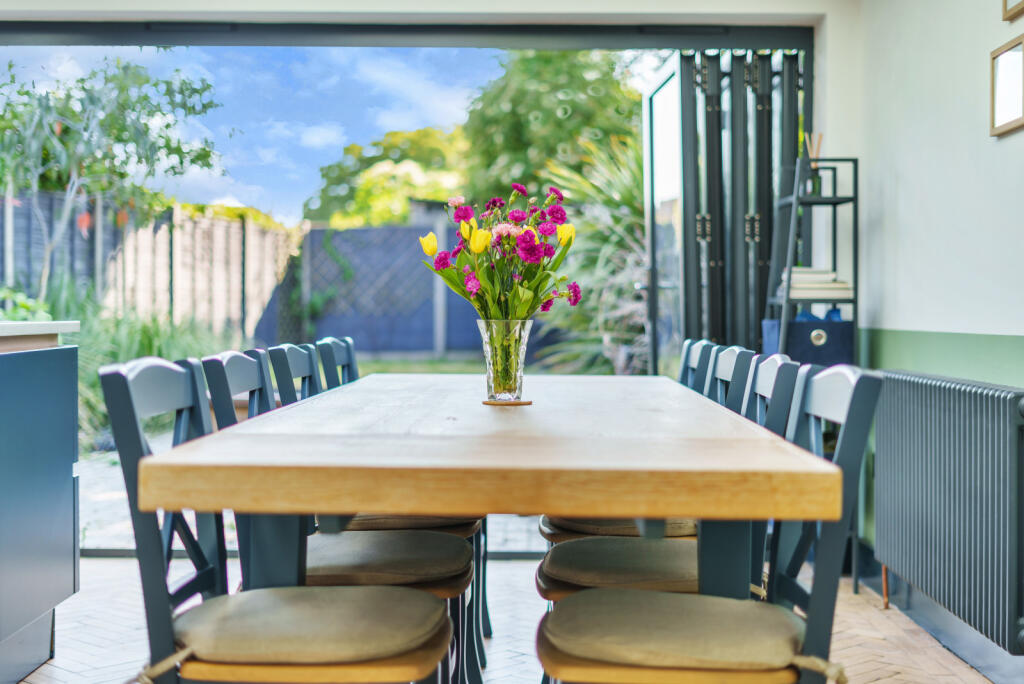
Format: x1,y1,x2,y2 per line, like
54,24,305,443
650,76,683,377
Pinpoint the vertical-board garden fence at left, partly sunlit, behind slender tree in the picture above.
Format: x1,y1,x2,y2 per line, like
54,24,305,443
0,191,300,341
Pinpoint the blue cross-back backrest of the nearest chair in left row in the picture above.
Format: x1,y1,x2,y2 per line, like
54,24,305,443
99,356,227,662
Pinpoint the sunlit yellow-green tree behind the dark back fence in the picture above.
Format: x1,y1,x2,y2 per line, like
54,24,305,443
304,127,466,228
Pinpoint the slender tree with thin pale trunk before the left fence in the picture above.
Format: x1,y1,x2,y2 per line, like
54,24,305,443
0,60,218,299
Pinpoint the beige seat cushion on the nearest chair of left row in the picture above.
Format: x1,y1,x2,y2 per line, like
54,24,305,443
174,587,447,665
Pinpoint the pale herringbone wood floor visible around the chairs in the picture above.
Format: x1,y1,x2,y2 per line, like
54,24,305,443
25,559,988,684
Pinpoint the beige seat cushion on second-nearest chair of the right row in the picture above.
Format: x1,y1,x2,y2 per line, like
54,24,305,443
541,537,698,593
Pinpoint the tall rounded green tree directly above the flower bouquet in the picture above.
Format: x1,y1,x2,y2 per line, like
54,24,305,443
464,50,640,204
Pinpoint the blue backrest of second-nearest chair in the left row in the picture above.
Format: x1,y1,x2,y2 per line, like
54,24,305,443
203,349,276,430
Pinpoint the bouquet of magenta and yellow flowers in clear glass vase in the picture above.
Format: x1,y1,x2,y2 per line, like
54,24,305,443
420,183,582,403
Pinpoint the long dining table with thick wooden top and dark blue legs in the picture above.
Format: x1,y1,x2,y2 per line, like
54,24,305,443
138,374,842,597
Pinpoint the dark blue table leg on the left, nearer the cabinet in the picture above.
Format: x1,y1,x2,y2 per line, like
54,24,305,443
238,515,307,590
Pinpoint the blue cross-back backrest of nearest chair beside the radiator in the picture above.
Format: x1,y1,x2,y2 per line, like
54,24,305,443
768,366,882,658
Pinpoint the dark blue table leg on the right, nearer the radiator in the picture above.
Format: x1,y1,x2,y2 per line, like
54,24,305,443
697,520,751,599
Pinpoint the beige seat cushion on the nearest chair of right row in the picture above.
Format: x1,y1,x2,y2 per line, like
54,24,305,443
542,589,804,670
